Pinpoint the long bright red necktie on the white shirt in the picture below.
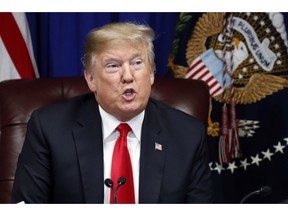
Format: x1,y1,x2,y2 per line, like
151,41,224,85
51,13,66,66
110,123,135,203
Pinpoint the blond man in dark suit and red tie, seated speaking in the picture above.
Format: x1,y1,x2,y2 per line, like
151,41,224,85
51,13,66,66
12,23,213,203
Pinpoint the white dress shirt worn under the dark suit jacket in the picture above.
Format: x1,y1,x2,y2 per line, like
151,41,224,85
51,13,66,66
99,105,145,203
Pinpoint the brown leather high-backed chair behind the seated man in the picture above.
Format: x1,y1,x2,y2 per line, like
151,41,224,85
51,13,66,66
0,77,209,203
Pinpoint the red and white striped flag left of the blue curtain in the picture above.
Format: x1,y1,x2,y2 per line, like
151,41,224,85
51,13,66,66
0,13,39,81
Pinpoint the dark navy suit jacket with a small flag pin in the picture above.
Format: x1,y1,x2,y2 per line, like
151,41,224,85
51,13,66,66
12,94,212,203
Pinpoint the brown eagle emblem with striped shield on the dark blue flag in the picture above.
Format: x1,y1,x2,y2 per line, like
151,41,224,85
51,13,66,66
168,12,288,136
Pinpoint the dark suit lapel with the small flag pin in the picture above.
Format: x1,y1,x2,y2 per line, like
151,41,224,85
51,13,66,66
139,102,166,203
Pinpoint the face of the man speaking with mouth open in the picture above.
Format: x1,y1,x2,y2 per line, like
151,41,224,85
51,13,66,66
85,40,154,121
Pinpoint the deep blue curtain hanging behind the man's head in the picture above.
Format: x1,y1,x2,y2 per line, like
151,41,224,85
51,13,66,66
27,12,179,77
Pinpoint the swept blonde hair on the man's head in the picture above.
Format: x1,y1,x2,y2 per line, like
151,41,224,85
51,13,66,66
82,22,156,71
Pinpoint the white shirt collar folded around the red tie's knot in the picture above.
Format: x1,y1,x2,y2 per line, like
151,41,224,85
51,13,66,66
99,105,145,143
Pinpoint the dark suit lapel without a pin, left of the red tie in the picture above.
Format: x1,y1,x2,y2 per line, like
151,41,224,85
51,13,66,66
73,100,104,203
